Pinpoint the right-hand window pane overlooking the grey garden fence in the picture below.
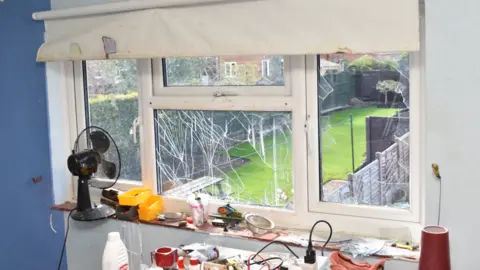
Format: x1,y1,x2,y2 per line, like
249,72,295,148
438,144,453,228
318,53,410,208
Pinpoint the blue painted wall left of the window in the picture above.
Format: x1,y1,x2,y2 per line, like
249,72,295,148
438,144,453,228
0,0,64,270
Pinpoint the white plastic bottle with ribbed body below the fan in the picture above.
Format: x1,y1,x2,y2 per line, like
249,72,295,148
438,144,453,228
102,232,128,270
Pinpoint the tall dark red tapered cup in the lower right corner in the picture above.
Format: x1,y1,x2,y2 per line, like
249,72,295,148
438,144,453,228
418,226,451,270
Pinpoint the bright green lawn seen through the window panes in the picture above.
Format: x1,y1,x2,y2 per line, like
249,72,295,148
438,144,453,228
218,107,396,203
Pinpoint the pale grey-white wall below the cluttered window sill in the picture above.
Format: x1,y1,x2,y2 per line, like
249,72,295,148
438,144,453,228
67,220,418,270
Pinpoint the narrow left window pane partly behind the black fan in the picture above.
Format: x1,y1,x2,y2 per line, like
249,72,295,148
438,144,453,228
85,60,141,181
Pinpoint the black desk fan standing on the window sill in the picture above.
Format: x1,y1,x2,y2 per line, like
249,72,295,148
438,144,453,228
67,126,121,221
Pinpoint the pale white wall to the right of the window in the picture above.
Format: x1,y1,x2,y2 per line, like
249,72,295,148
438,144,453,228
425,0,480,270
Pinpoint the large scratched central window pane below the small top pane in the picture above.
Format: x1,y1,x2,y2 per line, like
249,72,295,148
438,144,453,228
155,110,293,208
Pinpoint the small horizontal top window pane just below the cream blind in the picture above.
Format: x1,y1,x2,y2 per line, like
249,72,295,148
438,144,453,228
164,56,284,86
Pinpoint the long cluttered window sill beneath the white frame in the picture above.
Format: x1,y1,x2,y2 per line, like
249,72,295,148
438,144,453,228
51,202,420,262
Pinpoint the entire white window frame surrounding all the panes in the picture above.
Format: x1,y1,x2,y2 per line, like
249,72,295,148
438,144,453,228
71,53,423,241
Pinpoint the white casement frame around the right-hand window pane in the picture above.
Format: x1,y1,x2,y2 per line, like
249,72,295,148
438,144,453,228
307,52,424,222
